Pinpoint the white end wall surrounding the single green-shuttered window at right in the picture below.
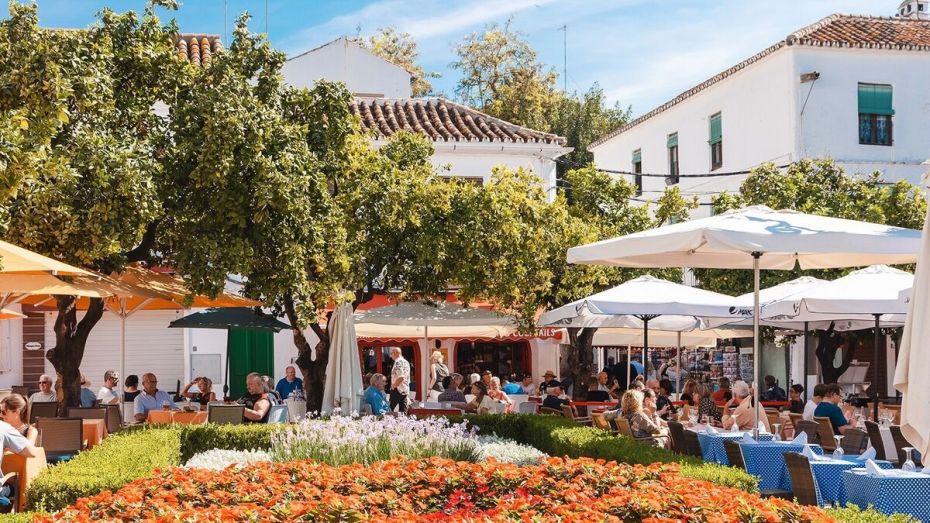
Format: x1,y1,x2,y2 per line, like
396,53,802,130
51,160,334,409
793,47,930,183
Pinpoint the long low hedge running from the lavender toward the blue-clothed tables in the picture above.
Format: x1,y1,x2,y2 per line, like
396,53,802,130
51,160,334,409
456,415,757,492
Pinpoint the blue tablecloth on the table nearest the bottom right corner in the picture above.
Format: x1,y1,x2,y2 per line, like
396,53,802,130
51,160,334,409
843,470,930,521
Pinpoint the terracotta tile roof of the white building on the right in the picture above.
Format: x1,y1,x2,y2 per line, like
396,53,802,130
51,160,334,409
591,14,930,147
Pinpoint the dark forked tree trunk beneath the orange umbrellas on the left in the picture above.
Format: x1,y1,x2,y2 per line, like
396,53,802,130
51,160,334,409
45,296,103,416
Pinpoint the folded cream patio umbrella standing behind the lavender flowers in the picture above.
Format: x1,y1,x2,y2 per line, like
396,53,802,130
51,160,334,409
320,303,362,414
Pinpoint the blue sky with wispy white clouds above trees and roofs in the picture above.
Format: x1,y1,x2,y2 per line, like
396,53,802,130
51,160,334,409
9,0,899,114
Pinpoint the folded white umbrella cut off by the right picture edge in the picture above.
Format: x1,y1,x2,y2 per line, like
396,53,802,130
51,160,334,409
894,207,930,460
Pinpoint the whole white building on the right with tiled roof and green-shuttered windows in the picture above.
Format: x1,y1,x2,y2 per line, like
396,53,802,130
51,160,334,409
591,12,930,216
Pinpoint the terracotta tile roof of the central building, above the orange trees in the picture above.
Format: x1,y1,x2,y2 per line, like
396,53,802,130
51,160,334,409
351,98,566,145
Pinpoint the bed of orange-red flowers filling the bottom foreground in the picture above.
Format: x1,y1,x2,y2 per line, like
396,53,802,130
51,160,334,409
37,458,832,522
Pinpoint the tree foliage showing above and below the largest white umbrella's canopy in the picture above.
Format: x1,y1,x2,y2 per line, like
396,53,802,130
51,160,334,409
695,159,927,295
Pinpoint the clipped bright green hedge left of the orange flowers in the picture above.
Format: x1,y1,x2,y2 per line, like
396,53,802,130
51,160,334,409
26,428,182,511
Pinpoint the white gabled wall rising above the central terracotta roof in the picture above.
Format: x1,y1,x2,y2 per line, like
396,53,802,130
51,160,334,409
281,38,411,98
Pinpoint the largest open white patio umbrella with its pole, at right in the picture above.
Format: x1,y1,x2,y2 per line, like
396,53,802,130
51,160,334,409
568,206,920,430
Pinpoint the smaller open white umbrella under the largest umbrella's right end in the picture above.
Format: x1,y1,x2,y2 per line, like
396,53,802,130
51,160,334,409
761,265,914,418
